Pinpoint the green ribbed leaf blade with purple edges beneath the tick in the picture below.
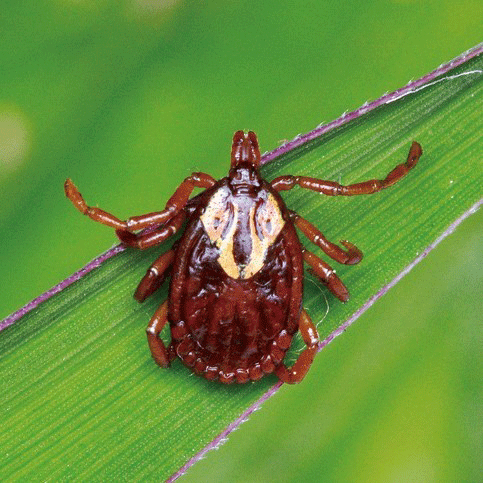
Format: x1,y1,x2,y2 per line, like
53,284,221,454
0,48,483,480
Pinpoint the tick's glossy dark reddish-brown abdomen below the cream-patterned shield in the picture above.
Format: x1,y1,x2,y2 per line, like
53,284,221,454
168,217,302,382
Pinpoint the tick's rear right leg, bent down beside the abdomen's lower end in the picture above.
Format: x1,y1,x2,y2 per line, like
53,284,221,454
275,309,319,384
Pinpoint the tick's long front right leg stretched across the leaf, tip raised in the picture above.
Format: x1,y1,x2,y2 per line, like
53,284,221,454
270,141,423,196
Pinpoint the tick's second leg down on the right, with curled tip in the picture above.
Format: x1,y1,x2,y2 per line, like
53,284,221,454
290,211,362,265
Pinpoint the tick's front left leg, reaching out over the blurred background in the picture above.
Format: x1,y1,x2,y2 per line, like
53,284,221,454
64,173,216,231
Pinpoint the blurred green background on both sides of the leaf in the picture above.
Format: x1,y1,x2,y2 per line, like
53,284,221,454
0,0,483,481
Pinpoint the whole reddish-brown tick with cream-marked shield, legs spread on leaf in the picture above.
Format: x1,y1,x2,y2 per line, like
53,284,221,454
65,131,422,383
